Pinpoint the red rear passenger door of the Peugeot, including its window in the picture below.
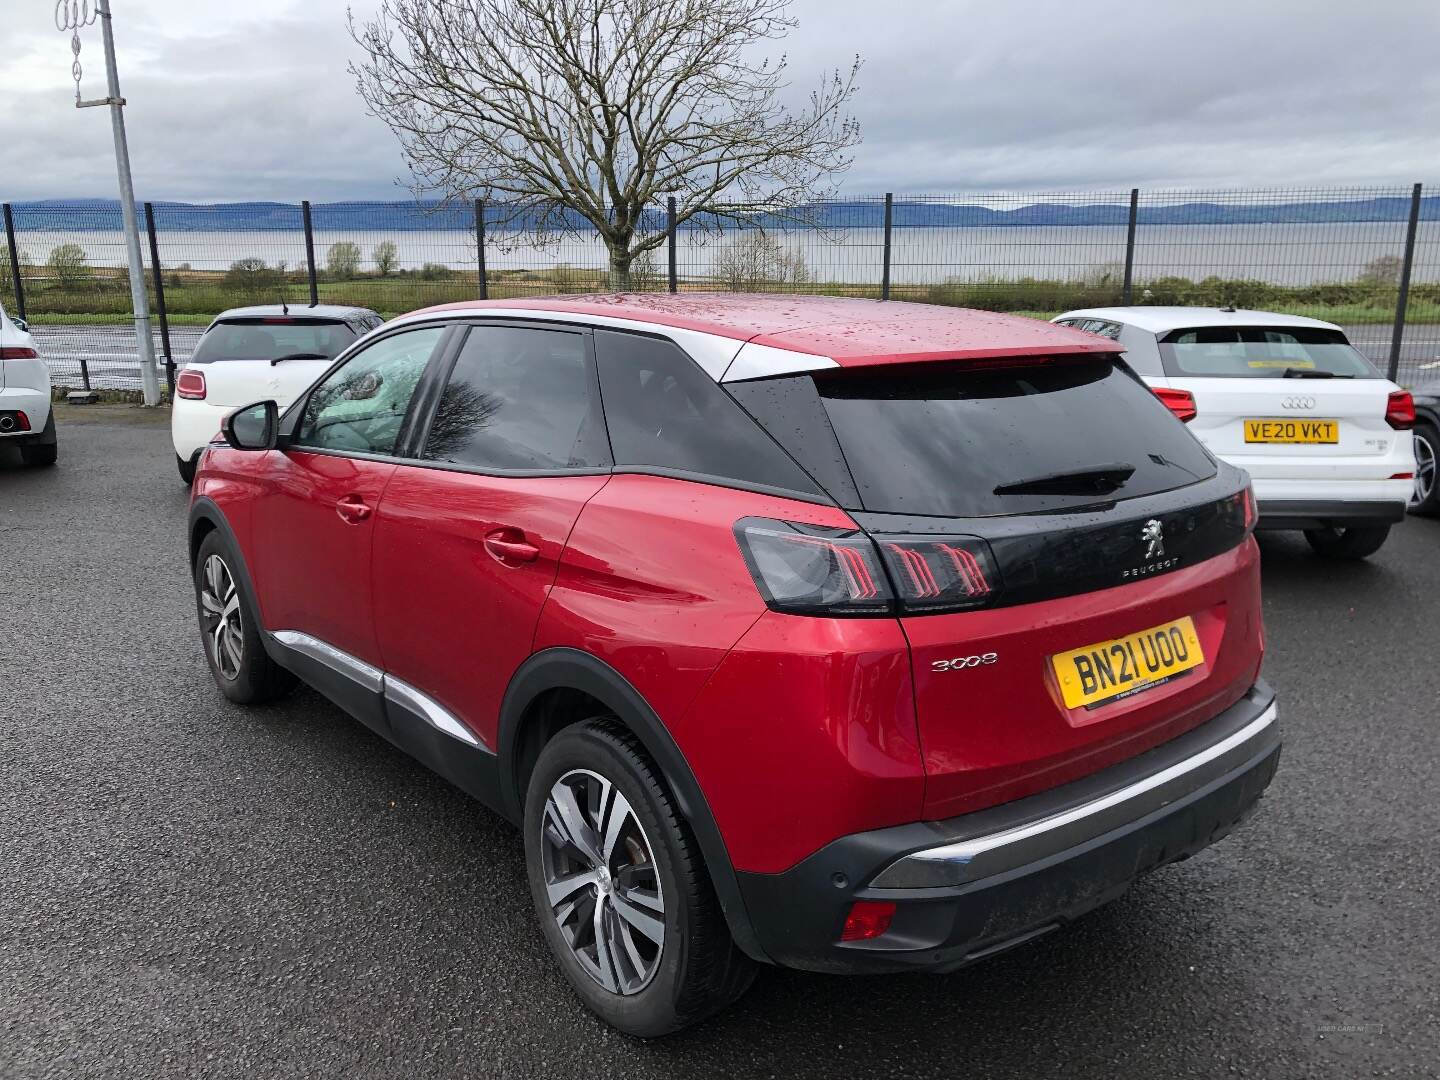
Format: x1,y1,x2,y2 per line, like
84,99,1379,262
373,324,609,760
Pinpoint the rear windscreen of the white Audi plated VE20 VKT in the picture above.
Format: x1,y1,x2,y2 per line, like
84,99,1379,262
1161,327,1380,379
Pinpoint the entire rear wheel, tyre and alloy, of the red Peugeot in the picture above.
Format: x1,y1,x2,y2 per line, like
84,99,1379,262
524,717,755,1038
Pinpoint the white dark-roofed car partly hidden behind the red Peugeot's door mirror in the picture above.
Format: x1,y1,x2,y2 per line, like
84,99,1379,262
170,304,384,484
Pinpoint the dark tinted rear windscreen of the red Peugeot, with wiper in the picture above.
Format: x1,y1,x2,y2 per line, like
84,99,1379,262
730,356,1215,517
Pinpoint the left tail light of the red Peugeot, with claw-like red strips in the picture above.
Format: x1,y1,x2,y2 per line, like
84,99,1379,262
736,517,999,615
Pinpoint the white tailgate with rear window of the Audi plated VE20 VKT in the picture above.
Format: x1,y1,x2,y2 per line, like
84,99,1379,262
1159,327,1401,480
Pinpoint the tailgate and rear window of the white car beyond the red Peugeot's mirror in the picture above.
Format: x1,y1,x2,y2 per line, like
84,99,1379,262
190,315,356,408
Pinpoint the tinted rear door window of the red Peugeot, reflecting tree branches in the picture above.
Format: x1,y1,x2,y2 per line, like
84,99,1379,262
422,325,609,472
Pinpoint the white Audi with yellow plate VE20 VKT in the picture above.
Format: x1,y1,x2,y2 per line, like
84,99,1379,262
1051,307,1416,559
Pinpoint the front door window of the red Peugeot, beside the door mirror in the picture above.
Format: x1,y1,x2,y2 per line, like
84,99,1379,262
292,327,445,454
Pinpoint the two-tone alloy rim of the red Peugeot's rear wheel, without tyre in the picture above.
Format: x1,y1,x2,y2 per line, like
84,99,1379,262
540,769,665,995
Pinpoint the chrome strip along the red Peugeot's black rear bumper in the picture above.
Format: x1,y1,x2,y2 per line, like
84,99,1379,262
870,703,1279,890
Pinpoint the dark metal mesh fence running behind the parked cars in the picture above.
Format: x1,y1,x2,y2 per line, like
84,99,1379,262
0,187,1440,387
